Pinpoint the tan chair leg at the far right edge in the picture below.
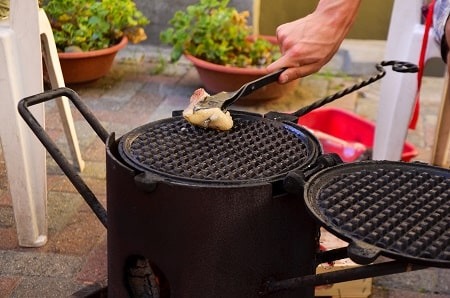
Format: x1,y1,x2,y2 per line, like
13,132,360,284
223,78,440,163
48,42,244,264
431,76,450,167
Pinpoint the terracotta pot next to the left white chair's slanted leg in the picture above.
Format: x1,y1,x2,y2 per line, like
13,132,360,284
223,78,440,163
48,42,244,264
58,37,128,84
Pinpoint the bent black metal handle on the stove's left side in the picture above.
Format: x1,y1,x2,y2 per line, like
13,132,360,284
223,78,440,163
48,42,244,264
18,88,109,227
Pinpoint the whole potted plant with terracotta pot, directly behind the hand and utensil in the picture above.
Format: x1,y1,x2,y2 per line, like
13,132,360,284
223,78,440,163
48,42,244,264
160,0,297,100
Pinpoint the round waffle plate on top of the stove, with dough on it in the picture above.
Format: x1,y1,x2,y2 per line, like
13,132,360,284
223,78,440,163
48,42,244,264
119,113,321,184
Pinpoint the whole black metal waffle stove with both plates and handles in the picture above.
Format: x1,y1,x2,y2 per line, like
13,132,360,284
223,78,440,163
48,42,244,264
15,63,450,297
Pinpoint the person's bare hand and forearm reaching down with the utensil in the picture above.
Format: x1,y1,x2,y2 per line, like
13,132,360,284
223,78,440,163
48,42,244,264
267,0,361,84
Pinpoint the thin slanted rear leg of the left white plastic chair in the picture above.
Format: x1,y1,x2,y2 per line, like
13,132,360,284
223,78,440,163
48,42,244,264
39,10,85,171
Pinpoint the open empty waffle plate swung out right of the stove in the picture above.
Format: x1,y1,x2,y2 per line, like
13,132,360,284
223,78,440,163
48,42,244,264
305,161,450,268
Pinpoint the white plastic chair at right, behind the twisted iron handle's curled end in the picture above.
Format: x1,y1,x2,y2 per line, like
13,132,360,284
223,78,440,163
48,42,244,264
373,0,441,164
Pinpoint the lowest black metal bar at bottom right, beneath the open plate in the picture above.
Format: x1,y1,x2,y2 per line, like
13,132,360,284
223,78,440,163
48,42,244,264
260,261,427,295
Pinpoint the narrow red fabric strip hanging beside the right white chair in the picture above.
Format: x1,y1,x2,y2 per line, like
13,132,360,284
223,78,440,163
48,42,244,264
409,0,435,129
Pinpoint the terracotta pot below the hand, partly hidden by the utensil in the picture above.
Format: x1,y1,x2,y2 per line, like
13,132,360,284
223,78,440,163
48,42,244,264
185,37,298,101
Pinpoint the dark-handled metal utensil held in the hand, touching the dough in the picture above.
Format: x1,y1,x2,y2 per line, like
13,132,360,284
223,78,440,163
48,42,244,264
194,68,286,111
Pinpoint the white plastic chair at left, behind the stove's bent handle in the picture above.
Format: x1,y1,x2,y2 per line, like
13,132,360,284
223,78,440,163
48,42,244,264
0,0,84,247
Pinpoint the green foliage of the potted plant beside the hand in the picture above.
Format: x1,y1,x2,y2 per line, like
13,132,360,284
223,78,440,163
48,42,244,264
160,0,279,66
